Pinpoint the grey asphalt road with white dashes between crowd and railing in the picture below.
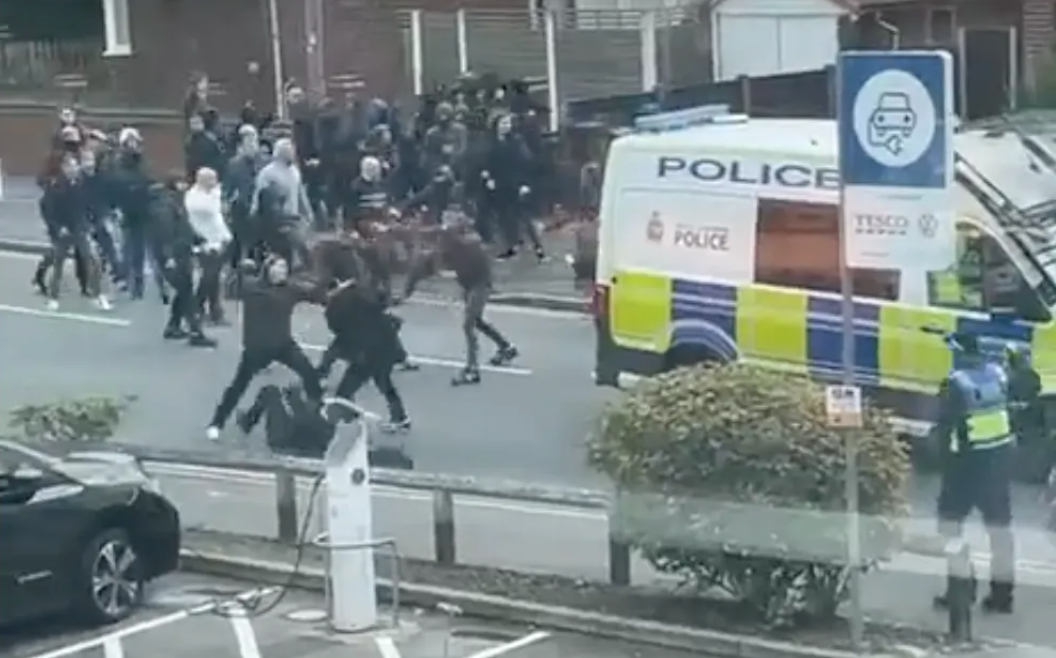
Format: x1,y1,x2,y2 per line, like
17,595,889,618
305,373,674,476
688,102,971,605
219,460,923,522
0,252,616,486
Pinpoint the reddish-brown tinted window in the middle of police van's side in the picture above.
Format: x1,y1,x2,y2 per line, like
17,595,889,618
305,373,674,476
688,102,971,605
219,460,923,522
755,199,899,300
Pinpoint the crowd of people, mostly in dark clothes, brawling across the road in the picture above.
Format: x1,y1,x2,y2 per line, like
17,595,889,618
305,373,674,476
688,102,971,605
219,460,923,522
34,73,587,447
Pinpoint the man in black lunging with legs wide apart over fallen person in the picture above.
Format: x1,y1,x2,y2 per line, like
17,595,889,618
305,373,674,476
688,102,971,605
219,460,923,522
206,257,324,440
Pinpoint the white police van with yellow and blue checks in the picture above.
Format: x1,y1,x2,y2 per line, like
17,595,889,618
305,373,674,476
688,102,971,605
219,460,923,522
593,108,1056,479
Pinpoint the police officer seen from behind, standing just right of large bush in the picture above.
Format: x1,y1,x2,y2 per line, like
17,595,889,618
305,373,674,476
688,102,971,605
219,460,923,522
935,333,1015,614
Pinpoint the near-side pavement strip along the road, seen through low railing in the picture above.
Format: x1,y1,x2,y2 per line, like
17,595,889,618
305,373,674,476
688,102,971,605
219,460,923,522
147,464,1056,646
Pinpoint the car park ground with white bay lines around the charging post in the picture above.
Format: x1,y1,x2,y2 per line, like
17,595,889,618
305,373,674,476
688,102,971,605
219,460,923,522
0,574,689,658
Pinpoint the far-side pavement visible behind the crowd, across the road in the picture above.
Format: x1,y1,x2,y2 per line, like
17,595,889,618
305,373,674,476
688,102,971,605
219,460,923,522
0,176,586,306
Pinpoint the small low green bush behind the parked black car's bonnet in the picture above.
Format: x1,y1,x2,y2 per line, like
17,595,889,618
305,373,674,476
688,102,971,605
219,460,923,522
10,396,134,441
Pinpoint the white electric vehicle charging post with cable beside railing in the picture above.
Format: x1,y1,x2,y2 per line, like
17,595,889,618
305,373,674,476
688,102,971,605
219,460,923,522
315,398,399,633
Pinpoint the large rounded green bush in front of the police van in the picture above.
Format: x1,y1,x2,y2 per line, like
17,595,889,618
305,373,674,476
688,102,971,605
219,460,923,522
588,363,909,626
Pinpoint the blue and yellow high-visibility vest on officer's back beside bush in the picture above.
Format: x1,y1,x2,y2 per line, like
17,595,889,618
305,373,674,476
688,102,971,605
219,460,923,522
949,363,1014,452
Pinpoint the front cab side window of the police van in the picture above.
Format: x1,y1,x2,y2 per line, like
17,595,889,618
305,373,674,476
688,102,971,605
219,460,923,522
927,222,1050,322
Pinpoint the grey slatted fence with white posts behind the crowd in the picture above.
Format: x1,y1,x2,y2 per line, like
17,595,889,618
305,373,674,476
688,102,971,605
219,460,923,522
308,3,711,127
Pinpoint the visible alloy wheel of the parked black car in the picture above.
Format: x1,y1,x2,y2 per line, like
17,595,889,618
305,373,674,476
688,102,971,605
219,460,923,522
77,528,144,624
